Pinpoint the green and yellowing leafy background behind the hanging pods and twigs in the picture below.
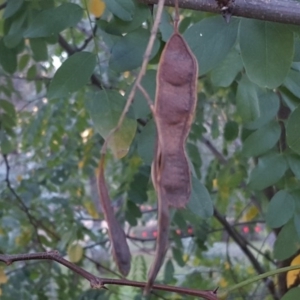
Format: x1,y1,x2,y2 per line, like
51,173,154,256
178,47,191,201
0,0,300,300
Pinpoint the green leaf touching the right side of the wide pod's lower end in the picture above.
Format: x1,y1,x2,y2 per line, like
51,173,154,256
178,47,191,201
187,176,214,218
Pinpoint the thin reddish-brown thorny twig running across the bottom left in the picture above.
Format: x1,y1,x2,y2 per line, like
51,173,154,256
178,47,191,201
0,251,218,300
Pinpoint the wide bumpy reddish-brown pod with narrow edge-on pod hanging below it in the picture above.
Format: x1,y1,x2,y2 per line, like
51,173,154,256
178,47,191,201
145,6,198,294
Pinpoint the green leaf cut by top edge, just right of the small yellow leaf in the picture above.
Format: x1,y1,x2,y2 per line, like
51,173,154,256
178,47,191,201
104,0,135,21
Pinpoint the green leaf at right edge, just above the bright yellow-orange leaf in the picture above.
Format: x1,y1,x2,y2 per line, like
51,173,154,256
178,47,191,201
274,221,300,260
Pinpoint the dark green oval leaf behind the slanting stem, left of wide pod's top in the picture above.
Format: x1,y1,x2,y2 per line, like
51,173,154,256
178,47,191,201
110,28,160,72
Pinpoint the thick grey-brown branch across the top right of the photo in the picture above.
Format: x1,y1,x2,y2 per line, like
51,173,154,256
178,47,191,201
139,0,300,25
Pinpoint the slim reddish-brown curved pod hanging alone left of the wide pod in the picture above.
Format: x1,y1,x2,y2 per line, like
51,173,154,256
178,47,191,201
98,155,131,276
